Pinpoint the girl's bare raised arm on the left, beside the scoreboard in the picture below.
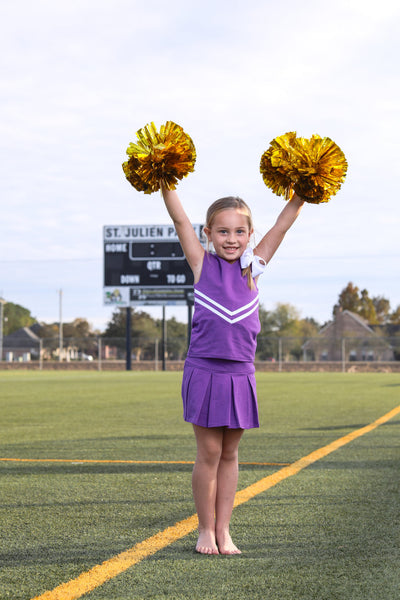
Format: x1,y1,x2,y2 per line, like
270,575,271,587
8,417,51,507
161,184,204,283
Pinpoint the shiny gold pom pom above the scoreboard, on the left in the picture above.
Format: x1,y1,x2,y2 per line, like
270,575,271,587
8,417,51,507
122,121,196,194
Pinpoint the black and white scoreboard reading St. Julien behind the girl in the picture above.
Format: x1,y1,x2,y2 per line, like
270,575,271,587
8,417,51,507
103,225,203,307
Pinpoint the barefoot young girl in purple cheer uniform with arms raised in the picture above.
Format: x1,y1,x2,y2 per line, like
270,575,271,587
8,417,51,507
162,186,303,554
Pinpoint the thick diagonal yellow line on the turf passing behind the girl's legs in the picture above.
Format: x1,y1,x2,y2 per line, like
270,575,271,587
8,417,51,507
32,405,400,600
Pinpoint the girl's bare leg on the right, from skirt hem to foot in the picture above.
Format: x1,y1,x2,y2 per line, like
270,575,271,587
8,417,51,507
215,429,243,554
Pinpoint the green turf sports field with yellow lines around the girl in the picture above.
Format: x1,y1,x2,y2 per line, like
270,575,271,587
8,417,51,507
0,372,400,600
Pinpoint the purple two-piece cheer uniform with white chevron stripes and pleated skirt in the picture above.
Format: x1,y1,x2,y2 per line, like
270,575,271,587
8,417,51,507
182,253,260,429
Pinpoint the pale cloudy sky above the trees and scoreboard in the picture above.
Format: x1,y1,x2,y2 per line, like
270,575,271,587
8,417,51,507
0,0,400,330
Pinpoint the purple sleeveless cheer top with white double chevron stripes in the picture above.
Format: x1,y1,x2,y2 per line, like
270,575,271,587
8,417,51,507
187,252,260,362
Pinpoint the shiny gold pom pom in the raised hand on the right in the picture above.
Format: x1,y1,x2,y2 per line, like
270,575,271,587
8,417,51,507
260,131,347,204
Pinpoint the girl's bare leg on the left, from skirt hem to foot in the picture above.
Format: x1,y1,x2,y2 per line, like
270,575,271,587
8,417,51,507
192,425,224,554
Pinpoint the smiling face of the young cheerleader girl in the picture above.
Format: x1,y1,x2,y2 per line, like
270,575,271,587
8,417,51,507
204,208,253,263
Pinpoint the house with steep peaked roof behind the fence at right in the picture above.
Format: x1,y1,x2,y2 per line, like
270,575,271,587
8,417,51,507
303,309,394,361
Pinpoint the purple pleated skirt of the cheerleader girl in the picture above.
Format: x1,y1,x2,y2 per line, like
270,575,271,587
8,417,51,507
182,358,259,429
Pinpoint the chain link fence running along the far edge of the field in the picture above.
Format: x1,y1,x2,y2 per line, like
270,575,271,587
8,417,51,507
1,335,400,370
